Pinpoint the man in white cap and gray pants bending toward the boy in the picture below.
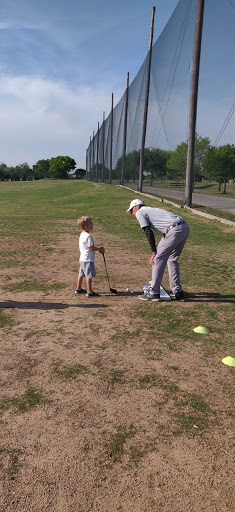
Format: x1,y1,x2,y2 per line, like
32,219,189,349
126,199,190,302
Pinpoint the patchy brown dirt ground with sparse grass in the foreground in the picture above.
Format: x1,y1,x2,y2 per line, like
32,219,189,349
0,226,234,512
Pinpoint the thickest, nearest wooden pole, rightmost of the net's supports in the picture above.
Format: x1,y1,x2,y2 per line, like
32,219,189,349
185,0,204,208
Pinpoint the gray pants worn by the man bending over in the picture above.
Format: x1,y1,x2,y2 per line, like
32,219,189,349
151,222,190,293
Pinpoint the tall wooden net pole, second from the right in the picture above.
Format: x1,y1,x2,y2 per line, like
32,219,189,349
139,7,155,192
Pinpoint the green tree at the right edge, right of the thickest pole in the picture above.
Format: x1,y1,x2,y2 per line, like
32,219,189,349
202,144,235,194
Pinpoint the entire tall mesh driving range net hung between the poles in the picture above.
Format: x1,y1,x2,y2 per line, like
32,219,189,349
88,0,235,182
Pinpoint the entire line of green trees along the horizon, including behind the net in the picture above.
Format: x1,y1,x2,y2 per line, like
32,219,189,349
0,134,235,193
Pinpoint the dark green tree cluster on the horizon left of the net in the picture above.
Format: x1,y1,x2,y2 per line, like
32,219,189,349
0,156,86,181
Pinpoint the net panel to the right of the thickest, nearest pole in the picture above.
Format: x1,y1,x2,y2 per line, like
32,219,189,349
197,0,235,146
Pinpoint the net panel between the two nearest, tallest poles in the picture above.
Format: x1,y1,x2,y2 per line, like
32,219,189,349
145,0,197,150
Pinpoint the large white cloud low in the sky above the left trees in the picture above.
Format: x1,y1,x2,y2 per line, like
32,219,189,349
0,76,120,167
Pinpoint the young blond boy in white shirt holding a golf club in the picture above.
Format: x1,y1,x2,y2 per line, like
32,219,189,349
75,217,104,297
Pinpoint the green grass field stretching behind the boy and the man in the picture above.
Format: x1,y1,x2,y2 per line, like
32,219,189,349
0,180,235,350
